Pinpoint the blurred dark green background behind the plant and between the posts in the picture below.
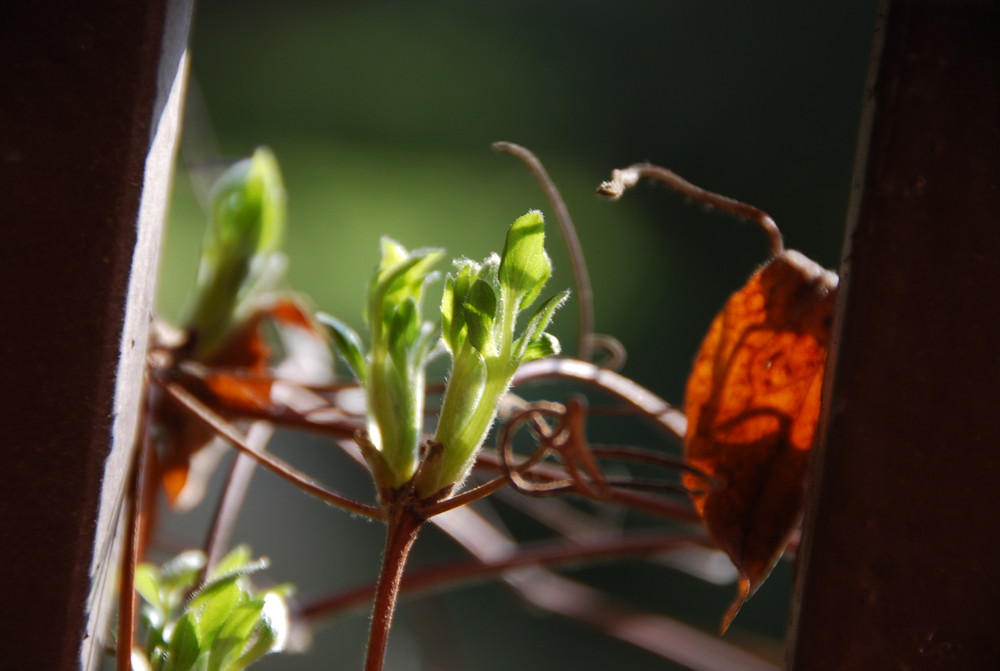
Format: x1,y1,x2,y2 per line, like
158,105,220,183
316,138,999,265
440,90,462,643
159,0,875,671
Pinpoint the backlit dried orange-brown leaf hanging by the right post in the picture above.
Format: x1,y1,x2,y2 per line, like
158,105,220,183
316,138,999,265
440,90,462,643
684,250,837,631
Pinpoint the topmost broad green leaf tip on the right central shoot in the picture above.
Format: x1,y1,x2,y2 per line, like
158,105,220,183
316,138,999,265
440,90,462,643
499,210,552,310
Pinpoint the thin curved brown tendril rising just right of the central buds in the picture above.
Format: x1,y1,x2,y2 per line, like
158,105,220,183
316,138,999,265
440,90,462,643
493,142,594,361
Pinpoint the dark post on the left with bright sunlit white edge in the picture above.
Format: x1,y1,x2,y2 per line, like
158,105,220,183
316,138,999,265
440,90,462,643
0,0,191,671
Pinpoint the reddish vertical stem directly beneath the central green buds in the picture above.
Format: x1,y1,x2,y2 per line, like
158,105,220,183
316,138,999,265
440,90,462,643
365,504,425,671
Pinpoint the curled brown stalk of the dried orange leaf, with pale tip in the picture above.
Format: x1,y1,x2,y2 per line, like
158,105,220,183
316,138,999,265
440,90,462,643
597,163,785,256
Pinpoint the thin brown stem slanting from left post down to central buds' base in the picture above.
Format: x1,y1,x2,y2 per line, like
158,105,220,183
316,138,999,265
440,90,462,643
163,382,384,519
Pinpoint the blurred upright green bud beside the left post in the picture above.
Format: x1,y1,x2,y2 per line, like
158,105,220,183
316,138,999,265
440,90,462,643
185,148,288,361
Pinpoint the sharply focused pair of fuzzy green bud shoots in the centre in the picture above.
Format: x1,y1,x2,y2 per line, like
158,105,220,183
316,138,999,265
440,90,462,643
320,211,569,498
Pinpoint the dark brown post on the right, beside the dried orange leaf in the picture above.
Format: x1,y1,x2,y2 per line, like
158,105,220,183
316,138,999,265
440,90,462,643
789,0,1000,671
